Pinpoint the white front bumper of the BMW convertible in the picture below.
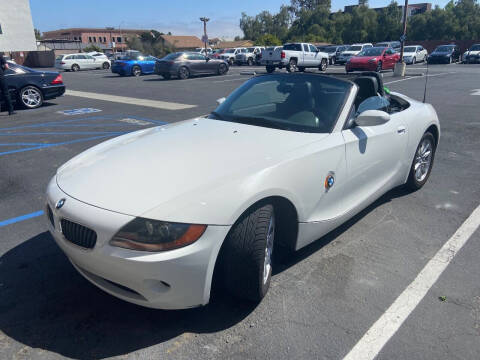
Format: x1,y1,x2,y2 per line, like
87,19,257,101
46,177,230,309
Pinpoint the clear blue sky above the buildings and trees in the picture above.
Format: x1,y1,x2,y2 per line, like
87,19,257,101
30,0,454,39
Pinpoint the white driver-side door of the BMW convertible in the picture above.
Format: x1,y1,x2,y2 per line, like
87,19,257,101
342,97,408,211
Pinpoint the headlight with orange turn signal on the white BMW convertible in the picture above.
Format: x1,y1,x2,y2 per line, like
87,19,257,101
110,218,207,251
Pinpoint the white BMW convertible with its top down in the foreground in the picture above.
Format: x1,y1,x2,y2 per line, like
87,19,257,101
46,73,440,309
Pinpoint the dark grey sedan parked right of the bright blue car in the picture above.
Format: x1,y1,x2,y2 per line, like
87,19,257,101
155,52,228,79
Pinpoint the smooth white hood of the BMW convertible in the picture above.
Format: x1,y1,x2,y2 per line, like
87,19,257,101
57,118,328,221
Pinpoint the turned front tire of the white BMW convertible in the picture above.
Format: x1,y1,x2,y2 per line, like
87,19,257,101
220,203,275,302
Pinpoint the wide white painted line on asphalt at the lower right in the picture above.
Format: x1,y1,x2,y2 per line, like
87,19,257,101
343,205,480,360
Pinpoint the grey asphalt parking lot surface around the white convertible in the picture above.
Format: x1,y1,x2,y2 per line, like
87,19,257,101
0,64,480,359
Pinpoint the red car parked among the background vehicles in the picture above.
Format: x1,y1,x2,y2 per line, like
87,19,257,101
345,47,400,73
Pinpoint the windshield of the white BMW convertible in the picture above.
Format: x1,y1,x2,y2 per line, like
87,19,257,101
209,74,352,133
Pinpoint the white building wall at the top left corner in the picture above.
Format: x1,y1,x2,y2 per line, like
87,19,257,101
0,0,37,52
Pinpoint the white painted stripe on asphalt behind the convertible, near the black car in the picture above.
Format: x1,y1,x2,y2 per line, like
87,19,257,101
65,90,197,110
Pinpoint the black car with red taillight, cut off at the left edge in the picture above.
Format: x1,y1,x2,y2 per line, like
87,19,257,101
0,62,65,109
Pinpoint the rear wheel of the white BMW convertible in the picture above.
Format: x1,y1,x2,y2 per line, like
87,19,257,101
406,131,436,191
